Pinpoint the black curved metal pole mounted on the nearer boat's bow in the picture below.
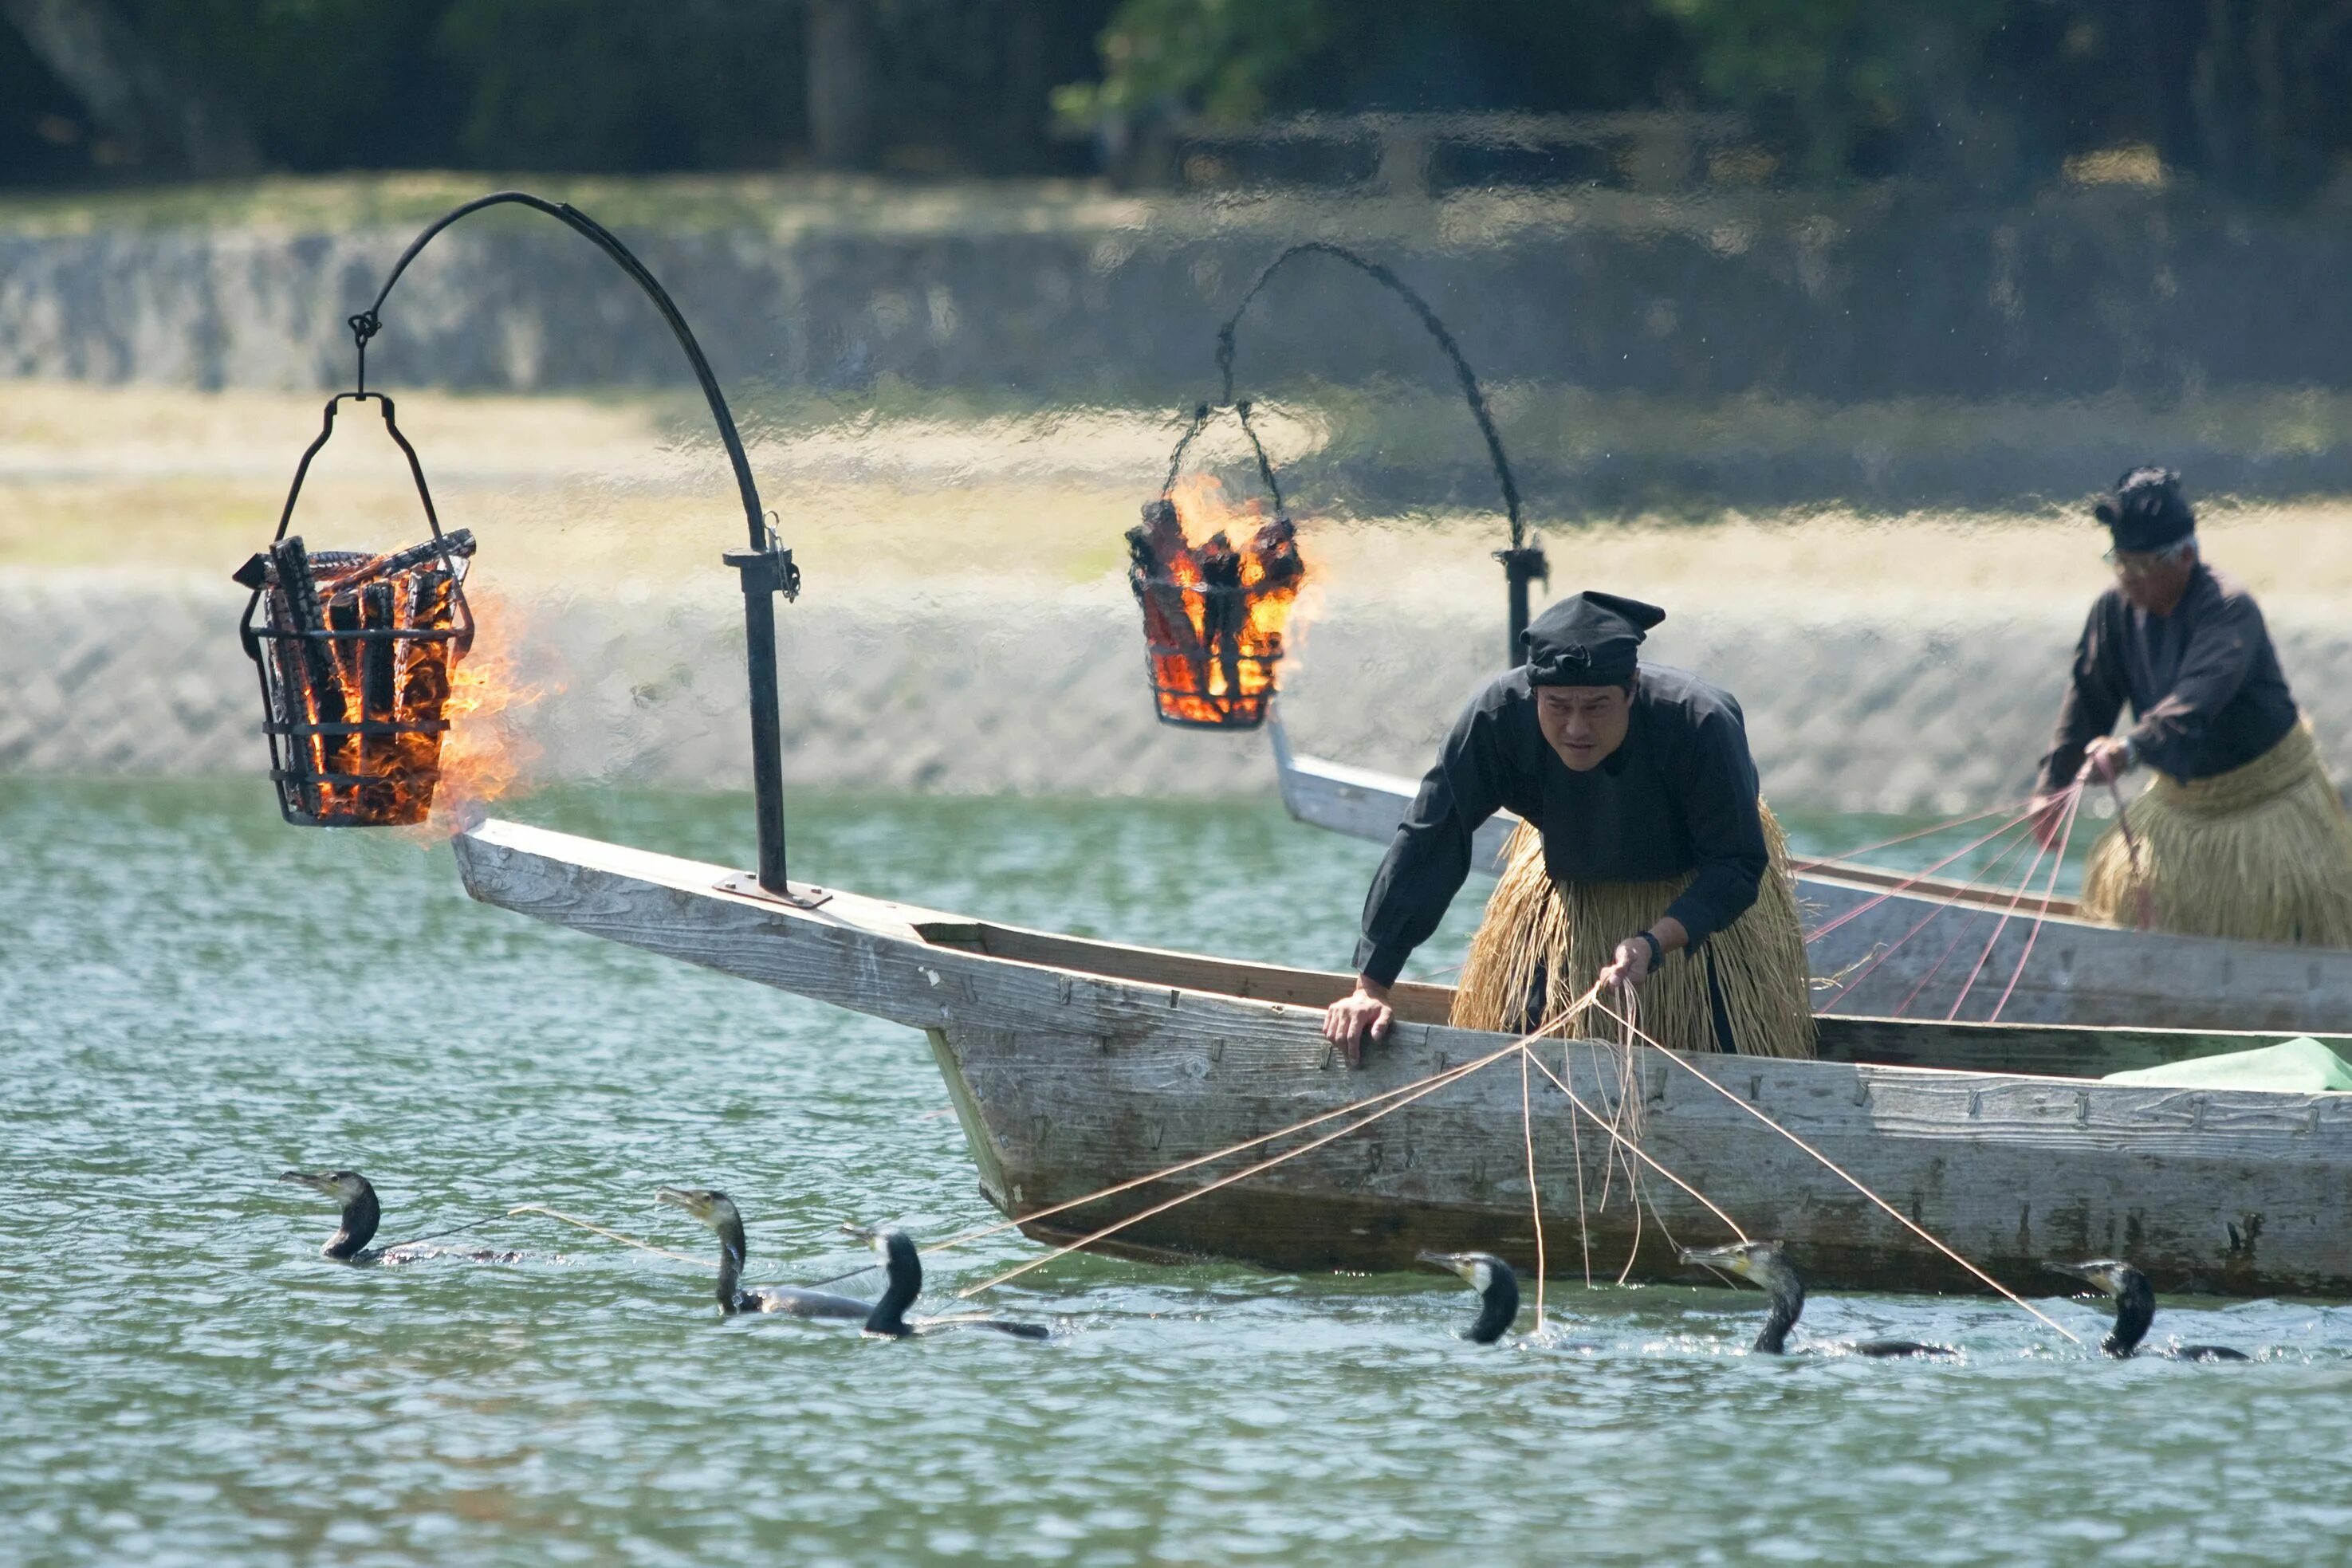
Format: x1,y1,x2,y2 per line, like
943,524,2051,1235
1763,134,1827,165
348,191,824,905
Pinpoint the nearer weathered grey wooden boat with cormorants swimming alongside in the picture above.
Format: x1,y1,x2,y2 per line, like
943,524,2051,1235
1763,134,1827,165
456,820,2352,1295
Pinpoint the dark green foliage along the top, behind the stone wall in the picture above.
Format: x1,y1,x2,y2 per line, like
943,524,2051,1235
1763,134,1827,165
0,0,2352,200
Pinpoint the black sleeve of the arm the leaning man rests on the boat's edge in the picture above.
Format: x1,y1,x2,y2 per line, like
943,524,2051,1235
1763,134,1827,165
1355,696,1505,985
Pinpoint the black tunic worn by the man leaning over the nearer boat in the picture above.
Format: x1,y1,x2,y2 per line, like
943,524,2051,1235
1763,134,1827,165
1355,666,1766,985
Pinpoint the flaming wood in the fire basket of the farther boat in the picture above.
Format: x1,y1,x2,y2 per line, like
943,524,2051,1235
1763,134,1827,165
1127,475,1305,729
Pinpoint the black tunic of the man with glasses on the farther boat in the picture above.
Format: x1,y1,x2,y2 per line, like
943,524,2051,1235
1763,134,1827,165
2042,562,2295,792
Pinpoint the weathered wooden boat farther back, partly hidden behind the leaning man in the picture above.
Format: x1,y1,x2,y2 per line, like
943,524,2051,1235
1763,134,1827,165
1268,717,2352,1032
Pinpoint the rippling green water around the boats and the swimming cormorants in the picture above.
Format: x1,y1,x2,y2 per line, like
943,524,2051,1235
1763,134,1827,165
0,780,2352,1563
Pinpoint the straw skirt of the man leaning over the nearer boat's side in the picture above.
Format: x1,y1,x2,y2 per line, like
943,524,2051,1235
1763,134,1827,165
1453,811,1813,1055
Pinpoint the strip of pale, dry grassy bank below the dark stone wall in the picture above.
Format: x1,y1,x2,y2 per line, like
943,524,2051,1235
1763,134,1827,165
14,383,2352,621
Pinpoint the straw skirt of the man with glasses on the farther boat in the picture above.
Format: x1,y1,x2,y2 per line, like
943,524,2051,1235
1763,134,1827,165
2082,719,2352,947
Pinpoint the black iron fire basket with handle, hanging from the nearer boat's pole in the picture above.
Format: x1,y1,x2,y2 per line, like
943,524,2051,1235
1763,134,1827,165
235,392,473,827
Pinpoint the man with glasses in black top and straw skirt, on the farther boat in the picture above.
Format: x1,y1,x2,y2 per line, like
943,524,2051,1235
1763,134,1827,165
2032,468,2352,947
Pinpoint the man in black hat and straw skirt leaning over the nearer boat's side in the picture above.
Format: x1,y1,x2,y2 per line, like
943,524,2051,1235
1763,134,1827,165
1324,592,1813,1060
